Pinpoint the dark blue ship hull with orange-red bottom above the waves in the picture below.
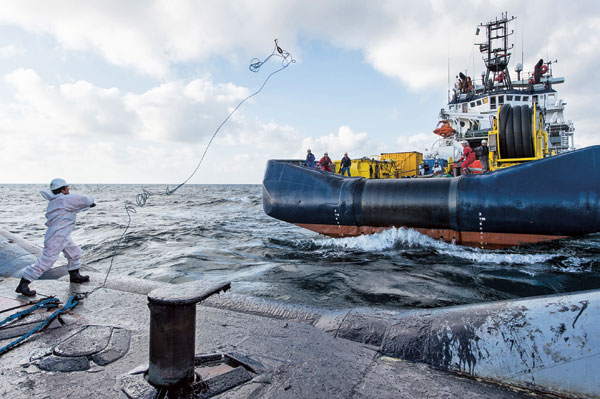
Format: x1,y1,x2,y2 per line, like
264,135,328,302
263,146,600,247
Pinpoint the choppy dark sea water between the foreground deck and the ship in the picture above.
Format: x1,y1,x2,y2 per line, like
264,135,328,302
0,184,600,310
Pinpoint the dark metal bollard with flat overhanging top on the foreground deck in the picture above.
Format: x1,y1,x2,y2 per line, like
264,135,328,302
148,281,231,388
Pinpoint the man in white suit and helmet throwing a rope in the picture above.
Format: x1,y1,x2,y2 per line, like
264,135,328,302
15,178,96,296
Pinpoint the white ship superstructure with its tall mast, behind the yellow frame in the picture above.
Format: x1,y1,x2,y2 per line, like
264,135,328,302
432,14,575,158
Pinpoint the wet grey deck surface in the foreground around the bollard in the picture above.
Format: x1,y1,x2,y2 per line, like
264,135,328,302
0,274,552,399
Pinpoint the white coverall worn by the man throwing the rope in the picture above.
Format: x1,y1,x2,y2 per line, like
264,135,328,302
23,191,94,281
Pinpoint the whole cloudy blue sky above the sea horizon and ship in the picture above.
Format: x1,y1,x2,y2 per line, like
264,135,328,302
0,0,600,185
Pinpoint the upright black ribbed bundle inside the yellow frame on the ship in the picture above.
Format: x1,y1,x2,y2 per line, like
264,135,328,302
499,104,535,158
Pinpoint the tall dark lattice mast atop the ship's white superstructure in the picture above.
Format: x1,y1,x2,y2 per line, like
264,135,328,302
476,12,515,91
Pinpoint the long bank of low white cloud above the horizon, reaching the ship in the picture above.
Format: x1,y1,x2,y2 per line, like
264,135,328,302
0,69,370,183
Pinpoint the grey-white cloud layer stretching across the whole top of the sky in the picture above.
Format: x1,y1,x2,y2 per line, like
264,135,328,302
0,0,600,90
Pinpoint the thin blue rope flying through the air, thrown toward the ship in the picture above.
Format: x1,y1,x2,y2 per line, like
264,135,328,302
83,39,296,297
